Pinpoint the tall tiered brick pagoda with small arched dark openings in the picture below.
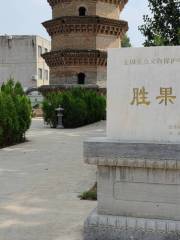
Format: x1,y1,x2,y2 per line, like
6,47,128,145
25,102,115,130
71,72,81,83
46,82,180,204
43,0,128,88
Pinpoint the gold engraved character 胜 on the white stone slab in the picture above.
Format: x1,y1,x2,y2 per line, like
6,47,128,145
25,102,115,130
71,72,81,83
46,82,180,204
131,87,150,106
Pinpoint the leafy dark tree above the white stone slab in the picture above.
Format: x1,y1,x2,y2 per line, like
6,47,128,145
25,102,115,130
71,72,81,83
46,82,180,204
139,0,180,47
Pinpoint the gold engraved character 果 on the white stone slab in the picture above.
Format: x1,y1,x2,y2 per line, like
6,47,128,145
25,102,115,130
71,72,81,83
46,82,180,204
156,87,176,106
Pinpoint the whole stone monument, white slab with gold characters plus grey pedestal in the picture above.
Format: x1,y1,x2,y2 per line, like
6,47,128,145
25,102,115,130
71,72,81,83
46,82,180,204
84,47,180,240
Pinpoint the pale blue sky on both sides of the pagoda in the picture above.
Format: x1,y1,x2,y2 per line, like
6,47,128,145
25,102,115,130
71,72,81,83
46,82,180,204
0,0,148,47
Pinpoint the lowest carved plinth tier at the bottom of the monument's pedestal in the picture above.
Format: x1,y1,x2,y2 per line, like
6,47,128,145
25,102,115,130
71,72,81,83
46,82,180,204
84,209,180,240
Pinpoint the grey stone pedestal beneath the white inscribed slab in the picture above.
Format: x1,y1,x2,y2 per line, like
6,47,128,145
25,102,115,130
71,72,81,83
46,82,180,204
84,138,180,240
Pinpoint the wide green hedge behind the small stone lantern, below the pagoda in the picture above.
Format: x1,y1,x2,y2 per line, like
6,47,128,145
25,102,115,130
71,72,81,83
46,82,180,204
43,88,106,128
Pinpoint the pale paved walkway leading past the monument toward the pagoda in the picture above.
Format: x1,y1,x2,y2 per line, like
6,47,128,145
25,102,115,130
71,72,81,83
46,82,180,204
0,119,105,240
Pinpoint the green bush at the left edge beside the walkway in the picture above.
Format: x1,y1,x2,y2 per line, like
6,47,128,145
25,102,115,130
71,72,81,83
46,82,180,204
0,80,31,147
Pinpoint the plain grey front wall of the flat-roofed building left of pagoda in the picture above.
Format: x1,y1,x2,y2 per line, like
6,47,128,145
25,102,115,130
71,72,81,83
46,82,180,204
0,36,50,88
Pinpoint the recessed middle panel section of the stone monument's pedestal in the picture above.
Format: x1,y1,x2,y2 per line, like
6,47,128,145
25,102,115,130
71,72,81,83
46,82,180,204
98,166,180,220
